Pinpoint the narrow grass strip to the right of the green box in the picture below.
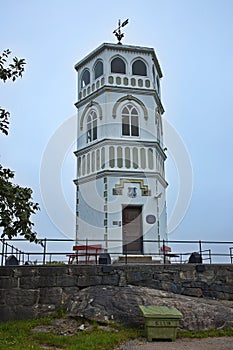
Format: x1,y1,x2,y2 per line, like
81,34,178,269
177,328,233,338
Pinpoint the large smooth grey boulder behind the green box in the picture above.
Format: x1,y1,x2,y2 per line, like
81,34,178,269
68,286,233,330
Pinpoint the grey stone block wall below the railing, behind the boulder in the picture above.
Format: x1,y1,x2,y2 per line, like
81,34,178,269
0,264,233,321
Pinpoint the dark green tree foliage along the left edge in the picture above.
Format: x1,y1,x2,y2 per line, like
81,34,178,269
0,50,41,243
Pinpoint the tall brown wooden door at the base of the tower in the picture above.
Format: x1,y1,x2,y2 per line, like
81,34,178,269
122,206,143,254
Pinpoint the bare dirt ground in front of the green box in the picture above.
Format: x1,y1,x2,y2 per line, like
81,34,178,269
115,337,233,350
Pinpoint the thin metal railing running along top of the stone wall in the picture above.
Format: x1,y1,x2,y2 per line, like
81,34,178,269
0,238,233,266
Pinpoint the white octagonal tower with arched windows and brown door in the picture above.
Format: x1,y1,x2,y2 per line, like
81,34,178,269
75,44,167,255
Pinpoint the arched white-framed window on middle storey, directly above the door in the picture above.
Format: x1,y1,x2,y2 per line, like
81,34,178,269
122,104,139,136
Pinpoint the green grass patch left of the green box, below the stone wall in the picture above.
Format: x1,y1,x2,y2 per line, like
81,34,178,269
0,317,142,350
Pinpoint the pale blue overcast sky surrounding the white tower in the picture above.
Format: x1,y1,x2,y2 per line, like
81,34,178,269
0,0,233,253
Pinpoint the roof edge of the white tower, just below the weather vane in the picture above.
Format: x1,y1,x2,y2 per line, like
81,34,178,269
74,43,163,78
